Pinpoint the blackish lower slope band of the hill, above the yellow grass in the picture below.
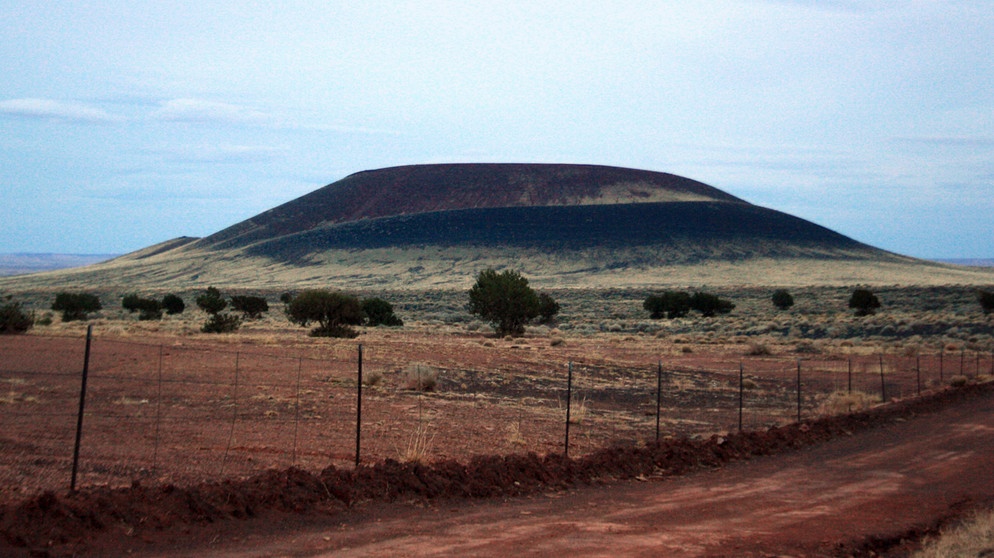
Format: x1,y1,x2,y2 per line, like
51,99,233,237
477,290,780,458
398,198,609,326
248,202,872,264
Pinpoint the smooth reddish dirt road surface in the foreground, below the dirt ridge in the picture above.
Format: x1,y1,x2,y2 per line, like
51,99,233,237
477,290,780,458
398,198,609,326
138,390,994,557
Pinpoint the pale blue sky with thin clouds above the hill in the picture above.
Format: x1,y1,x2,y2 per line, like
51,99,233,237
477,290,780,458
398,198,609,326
0,0,994,258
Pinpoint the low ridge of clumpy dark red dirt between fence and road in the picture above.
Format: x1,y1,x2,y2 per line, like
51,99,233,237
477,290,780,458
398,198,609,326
0,384,994,556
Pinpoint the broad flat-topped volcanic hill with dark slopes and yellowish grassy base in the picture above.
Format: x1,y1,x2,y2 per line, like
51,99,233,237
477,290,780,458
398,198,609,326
0,164,994,289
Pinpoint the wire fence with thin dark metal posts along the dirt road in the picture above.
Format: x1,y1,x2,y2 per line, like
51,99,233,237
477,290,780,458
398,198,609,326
0,336,994,504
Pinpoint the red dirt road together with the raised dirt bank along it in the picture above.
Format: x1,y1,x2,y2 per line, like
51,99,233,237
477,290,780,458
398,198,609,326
0,384,994,556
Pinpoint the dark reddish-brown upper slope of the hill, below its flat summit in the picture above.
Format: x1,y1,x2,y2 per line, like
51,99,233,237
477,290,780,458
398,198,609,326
196,164,744,249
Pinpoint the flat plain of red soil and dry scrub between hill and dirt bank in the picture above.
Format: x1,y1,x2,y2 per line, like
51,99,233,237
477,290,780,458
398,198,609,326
0,284,994,556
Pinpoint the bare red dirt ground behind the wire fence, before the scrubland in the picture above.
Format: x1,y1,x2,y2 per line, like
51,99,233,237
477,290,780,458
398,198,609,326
0,332,928,503
